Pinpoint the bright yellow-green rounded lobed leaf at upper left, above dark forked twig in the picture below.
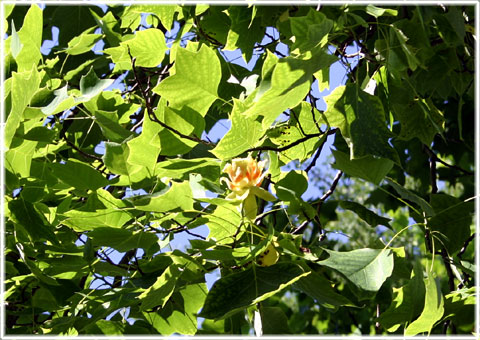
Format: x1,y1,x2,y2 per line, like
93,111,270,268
104,28,167,71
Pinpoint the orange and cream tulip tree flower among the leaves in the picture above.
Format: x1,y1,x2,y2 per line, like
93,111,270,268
221,155,275,220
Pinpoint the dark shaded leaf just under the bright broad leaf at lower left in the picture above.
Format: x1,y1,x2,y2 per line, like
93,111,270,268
87,227,158,252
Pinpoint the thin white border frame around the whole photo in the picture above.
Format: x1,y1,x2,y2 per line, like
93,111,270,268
0,0,480,340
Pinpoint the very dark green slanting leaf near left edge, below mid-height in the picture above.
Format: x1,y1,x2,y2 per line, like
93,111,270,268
8,198,57,243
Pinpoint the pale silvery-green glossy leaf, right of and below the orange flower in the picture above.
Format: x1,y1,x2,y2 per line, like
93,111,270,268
317,248,393,292
